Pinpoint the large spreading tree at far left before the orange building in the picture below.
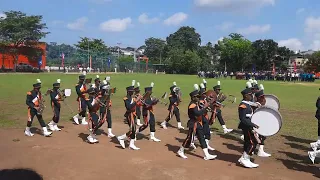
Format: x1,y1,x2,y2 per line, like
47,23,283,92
0,11,49,70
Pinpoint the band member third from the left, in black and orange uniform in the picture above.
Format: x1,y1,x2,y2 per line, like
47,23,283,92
73,75,89,125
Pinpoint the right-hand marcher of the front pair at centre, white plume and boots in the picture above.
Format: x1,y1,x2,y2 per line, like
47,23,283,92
137,82,161,142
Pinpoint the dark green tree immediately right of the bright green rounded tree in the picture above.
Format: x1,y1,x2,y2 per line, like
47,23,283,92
252,39,278,70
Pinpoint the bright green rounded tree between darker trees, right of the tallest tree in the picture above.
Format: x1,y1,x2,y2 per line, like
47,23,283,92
215,33,253,71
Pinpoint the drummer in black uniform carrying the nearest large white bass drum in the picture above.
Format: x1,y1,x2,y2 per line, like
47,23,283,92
238,88,259,168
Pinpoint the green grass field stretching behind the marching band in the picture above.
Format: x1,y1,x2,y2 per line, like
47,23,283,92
0,74,320,139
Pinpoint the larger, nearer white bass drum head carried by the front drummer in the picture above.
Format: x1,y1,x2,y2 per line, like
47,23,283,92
251,106,282,136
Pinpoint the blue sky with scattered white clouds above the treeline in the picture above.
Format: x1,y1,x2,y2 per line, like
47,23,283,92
0,0,320,51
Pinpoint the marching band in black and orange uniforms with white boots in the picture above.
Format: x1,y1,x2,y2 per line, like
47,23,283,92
25,74,284,168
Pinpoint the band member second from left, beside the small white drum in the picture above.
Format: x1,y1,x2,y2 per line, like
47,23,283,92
48,79,64,131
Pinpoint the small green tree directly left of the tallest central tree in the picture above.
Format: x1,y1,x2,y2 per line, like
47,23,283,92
144,37,166,63
